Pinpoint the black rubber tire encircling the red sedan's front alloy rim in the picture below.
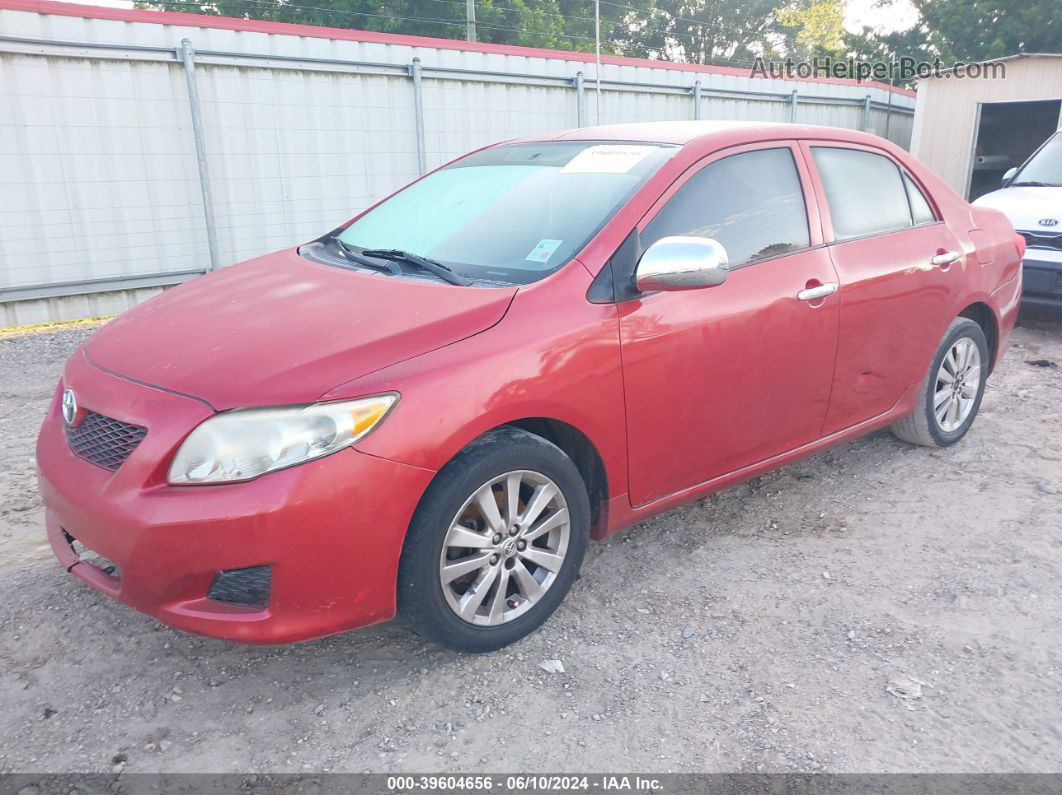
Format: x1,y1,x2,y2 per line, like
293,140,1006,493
397,427,590,653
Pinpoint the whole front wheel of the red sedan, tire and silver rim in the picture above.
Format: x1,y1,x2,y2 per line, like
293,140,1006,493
398,428,589,652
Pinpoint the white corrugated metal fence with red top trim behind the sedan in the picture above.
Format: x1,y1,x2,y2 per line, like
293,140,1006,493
0,2,913,327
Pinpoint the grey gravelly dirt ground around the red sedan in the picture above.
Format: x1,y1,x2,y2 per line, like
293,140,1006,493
0,317,1062,773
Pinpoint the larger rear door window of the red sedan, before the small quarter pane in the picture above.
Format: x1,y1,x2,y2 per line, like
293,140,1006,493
811,146,911,240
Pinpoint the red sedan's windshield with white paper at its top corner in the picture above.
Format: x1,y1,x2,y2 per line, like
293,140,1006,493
339,141,678,283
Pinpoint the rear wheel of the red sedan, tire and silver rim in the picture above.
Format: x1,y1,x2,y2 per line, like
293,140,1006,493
891,317,989,447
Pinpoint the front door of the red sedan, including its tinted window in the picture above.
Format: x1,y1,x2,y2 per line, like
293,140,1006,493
619,142,838,506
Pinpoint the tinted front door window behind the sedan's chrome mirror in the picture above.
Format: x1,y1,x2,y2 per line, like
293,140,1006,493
641,148,810,267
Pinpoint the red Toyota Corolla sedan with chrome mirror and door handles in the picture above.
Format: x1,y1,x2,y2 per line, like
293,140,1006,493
37,122,1024,652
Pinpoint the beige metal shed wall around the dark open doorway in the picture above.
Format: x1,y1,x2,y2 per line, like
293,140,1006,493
911,55,1062,195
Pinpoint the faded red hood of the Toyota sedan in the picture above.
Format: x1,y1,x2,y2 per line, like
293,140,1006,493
86,249,516,411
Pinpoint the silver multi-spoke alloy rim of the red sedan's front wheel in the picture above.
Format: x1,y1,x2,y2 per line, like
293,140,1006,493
439,469,571,626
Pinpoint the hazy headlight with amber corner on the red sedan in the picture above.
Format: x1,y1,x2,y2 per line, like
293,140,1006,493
169,395,398,485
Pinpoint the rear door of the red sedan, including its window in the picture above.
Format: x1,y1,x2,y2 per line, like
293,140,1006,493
802,141,970,435
